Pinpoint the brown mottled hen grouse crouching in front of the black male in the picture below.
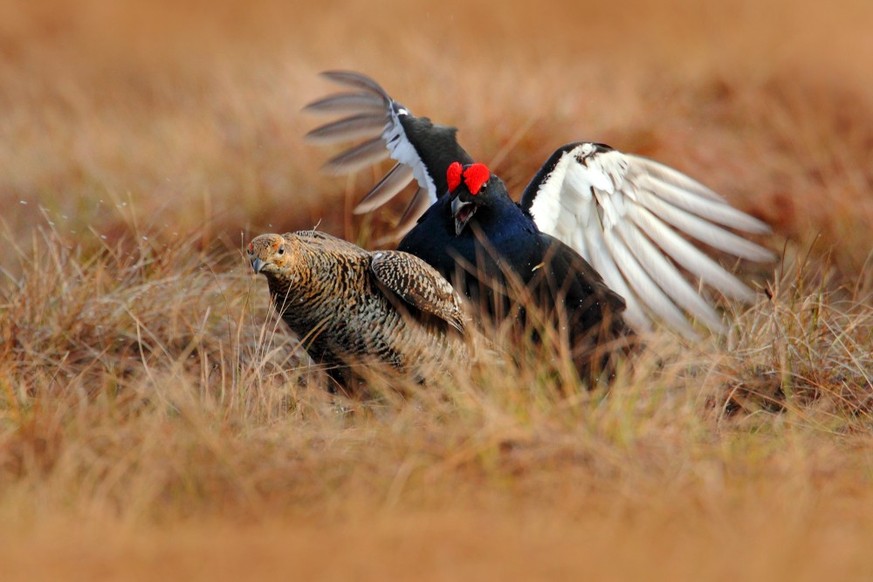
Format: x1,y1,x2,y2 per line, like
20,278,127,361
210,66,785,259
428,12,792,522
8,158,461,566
248,230,467,387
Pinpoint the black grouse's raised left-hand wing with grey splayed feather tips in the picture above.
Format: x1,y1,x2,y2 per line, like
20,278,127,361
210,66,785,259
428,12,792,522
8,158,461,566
304,71,473,239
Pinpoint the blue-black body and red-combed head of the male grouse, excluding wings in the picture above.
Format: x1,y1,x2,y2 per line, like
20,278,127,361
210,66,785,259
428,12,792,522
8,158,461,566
398,163,632,377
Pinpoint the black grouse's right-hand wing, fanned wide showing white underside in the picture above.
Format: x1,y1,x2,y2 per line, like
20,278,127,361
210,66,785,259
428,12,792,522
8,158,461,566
521,143,774,337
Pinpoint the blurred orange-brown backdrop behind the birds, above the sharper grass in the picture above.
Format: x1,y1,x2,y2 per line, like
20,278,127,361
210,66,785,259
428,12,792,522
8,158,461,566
0,0,873,277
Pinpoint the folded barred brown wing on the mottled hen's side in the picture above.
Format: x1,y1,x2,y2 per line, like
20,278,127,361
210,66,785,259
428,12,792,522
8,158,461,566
370,251,465,333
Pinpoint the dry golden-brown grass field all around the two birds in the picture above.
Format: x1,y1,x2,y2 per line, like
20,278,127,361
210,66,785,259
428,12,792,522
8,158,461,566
0,0,873,581
